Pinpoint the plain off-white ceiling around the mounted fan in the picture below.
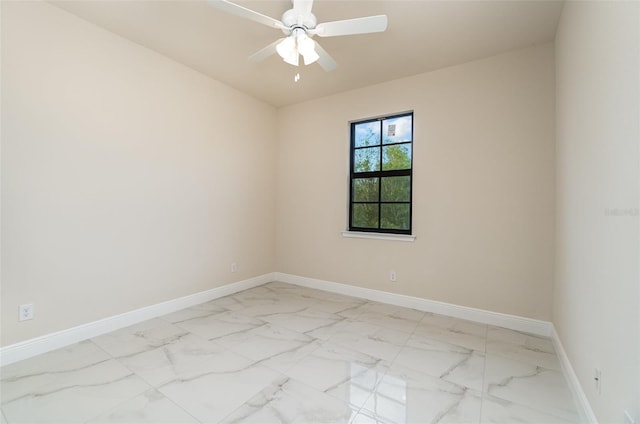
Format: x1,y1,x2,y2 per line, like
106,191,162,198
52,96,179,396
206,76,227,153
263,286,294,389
52,0,562,106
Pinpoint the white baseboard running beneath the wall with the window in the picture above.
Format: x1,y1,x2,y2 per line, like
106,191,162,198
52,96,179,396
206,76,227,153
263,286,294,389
275,272,553,337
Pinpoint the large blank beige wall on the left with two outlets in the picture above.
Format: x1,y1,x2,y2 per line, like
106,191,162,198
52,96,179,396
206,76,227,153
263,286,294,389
1,2,276,346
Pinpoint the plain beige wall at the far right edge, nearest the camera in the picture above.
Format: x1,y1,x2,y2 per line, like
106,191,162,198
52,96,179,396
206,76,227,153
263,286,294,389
553,2,640,423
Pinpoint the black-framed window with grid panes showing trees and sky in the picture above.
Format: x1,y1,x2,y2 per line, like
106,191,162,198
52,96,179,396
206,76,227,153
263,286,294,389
349,113,413,234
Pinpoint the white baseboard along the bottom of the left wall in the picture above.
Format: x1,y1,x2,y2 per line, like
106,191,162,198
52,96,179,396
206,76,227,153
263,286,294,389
0,273,276,366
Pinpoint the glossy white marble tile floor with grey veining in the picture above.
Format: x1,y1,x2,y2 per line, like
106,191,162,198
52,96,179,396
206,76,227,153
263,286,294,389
0,282,579,424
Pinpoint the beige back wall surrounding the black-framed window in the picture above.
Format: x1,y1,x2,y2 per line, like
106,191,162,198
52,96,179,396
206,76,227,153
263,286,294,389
277,44,554,320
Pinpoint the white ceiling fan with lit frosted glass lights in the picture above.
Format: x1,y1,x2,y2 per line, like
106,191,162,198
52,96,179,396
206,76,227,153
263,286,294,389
209,0,387,71
